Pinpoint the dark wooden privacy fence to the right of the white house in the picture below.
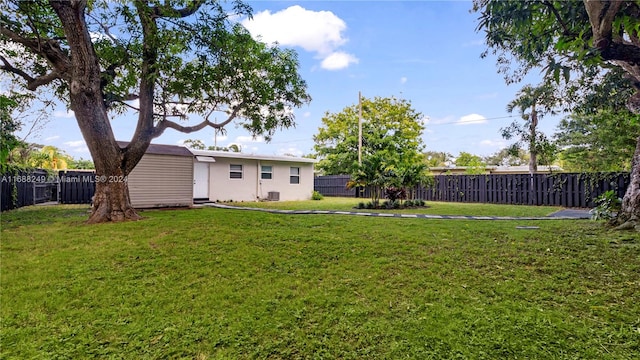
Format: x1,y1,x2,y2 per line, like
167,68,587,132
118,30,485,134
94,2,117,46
315,173,629,207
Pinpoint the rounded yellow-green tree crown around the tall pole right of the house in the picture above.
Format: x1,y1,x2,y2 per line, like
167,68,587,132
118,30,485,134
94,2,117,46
314,97,424,175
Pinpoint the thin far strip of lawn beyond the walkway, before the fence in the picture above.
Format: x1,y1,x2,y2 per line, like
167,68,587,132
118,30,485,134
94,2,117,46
227,197,562,217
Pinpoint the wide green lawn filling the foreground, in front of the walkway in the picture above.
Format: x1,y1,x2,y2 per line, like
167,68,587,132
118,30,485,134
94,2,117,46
0,202,640,359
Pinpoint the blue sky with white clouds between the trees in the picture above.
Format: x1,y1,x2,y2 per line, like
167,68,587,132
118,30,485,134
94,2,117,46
17,1,557,159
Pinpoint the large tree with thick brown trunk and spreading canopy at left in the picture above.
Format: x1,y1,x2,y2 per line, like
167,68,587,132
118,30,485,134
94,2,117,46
0,0,310,222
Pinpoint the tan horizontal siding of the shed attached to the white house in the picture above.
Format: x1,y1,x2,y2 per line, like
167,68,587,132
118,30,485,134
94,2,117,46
128,152,193,208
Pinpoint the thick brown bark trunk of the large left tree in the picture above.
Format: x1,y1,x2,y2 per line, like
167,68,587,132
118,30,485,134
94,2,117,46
51,1,148,223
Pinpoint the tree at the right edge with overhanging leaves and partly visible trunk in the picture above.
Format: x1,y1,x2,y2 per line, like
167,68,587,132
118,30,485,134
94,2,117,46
474,0,640,227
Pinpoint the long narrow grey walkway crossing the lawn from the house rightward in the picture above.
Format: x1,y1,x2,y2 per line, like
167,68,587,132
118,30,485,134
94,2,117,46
201,202,590,220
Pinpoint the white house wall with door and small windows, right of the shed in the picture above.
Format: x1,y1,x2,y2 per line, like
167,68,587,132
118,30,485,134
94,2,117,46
190,149,315,201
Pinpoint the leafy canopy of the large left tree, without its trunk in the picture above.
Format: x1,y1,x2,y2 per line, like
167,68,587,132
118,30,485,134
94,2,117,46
0,1,310,143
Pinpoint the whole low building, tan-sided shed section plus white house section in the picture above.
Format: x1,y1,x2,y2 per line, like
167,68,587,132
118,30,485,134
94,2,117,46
118,142,315,208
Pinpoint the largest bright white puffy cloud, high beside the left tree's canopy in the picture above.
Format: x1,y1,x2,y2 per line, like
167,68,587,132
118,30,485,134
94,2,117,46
242,5,358,70
